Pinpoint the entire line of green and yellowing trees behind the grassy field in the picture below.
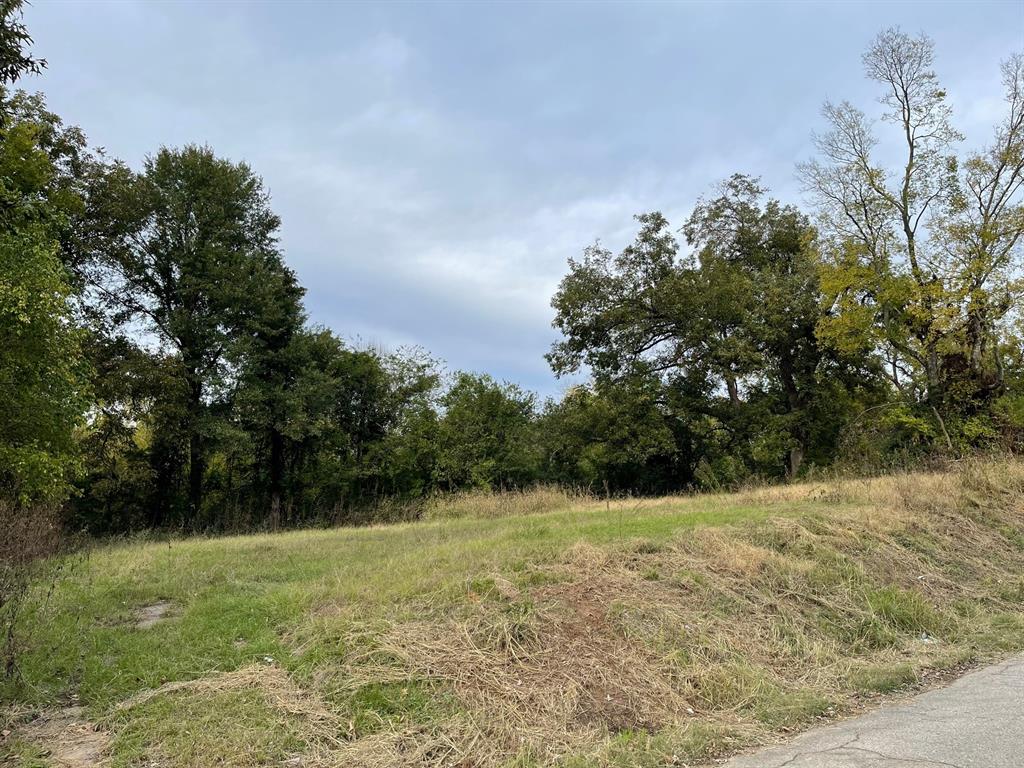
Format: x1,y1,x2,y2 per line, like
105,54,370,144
0,0,1024,534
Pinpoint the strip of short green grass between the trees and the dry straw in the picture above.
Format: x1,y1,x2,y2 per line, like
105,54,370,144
0,500,796,715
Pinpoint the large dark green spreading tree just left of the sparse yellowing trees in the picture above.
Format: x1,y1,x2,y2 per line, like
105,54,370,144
549,176,884,484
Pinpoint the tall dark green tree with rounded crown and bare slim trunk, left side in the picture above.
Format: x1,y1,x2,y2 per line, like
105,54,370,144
95,145,287,522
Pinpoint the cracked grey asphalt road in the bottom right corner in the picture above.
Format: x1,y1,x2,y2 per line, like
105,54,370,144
725,656,1024,768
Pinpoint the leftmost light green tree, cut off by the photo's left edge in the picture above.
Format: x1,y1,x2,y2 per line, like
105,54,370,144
0,19,85,504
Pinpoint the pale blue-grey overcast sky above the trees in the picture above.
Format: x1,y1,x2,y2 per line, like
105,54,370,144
24,0,1024,394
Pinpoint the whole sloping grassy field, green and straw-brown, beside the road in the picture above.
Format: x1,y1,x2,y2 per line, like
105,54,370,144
0,461,1024,768
